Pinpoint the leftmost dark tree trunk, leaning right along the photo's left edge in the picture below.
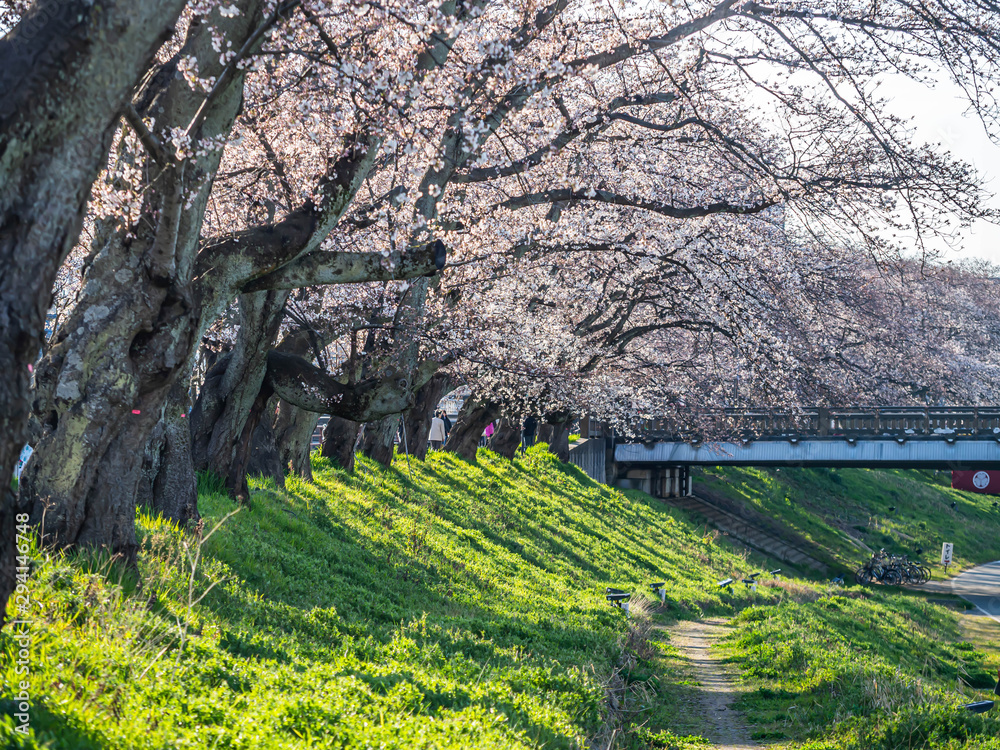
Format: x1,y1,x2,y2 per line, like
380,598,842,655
0,0,184,625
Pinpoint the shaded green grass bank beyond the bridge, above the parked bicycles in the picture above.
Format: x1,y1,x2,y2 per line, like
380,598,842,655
694,467,1000,577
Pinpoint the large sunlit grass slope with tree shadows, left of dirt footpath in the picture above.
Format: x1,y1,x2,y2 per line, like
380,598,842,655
0,446,780,750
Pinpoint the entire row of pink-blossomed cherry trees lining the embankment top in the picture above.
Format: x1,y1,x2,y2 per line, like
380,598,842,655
0,0,1000,624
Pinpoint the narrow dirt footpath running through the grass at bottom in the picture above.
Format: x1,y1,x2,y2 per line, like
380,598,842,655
670,619,759,750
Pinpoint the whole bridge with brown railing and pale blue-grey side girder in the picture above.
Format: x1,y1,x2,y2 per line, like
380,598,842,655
571,406,1000,497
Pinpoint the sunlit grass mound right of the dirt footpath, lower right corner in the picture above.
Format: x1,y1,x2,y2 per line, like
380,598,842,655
722,585,1000,750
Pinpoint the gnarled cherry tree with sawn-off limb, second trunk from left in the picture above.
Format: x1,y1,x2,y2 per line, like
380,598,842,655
21,2,458,540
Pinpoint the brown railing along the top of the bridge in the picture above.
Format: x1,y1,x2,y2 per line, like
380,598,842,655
581,406,1000,441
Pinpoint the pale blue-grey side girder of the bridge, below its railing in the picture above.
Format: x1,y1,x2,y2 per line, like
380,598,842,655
615,438,1000,470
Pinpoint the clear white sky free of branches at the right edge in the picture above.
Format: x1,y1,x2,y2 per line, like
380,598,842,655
881,76,1000,264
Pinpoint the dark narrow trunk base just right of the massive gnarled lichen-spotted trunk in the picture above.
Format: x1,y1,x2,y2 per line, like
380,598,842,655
136,379,198,526
